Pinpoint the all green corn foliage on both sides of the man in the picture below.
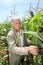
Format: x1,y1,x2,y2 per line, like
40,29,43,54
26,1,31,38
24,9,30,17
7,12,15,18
0,9,43,65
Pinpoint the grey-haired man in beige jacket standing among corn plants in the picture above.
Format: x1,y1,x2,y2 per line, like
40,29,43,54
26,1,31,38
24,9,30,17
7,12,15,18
7,17,38,65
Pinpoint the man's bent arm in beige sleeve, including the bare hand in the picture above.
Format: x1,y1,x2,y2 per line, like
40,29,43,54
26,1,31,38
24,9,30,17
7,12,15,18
7,34,38,55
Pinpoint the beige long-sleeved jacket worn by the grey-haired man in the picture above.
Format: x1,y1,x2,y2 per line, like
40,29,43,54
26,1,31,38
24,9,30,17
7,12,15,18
7,30,28,65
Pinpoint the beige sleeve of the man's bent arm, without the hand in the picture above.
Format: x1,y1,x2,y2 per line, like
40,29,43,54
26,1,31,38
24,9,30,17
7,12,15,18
7,35,28,55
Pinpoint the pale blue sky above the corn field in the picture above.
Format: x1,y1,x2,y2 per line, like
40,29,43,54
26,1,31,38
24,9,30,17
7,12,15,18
0,0,43,23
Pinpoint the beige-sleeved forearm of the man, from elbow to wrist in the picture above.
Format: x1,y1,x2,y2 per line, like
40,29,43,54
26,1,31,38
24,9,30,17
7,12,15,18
10,46,28,55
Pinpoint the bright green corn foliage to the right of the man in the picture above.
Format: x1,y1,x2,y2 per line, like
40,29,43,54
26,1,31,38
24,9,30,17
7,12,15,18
21,9,43,65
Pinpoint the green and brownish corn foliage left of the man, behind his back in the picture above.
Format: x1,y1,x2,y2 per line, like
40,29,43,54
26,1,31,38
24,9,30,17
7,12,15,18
0,20,11,65
